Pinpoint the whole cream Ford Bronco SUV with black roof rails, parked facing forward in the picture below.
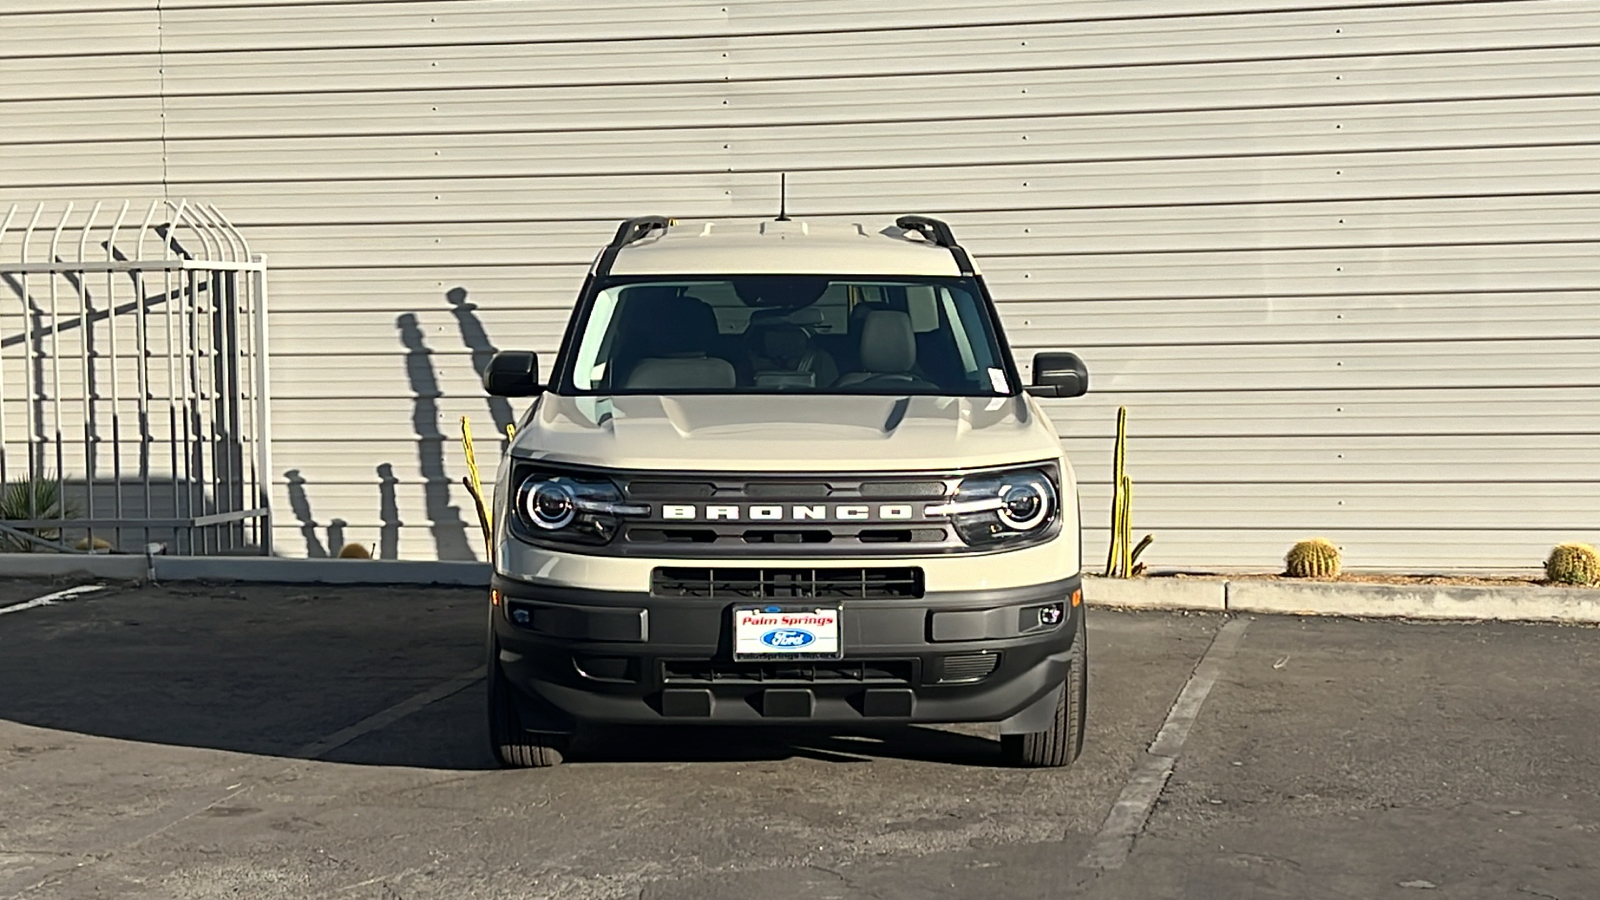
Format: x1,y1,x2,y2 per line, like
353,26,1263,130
483,216,1088,765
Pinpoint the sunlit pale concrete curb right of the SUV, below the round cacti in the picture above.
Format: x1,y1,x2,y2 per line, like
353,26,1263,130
1083,577,1600,623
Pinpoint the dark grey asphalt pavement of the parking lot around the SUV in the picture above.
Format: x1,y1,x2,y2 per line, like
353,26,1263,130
0,580,1600,900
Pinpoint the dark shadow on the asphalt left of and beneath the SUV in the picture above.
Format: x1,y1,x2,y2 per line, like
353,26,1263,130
0,585,1002,770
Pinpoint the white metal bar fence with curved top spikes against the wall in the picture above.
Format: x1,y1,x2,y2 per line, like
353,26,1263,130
0,200,272,554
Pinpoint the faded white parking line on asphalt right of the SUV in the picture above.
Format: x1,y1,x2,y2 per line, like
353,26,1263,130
1078,618,1250,870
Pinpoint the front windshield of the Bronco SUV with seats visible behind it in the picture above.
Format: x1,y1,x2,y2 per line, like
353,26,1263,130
568,275,1016,397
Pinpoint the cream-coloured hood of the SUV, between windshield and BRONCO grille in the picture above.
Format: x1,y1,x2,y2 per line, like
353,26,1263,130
510,394,1061,472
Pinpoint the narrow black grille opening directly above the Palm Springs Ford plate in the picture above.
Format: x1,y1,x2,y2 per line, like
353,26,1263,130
650,567,923,601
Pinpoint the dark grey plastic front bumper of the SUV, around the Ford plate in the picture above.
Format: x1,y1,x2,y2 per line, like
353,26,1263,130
490,575,1083,732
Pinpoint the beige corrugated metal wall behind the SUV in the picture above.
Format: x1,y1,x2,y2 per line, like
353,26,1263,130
0,0,1600,569
